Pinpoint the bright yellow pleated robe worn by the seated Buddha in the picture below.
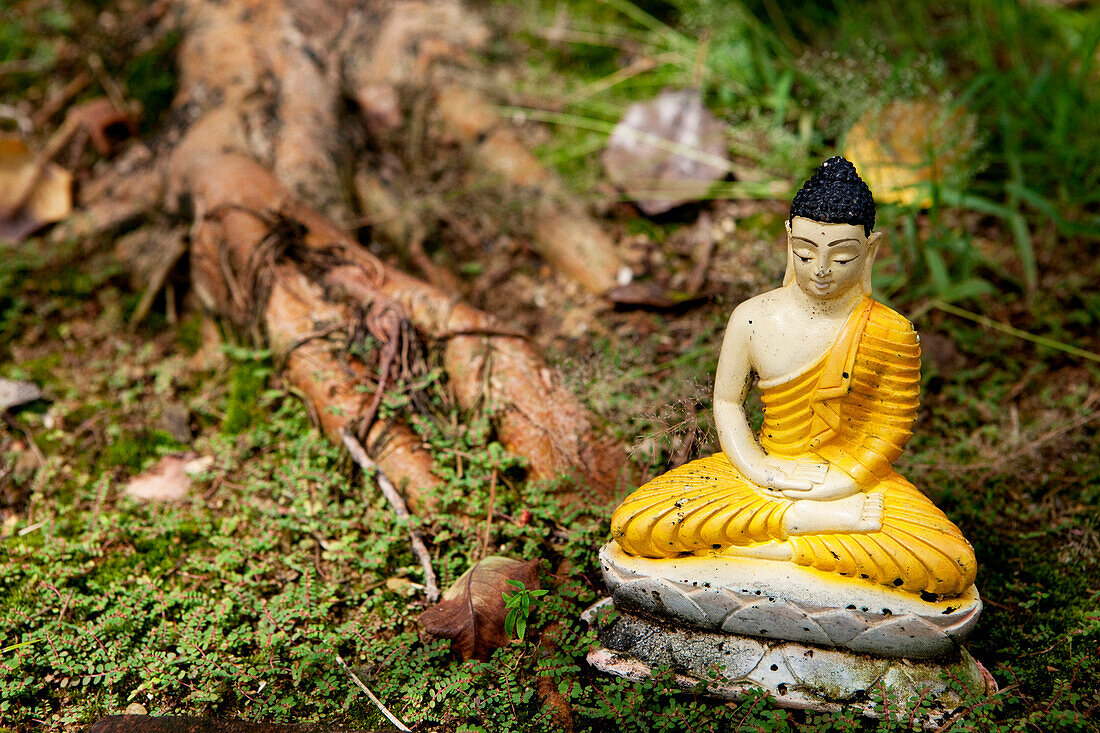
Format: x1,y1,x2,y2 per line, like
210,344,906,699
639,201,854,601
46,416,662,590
612,298,977,597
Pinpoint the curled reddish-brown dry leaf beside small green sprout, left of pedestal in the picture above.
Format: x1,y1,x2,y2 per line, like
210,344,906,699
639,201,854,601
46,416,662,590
420,556,539,660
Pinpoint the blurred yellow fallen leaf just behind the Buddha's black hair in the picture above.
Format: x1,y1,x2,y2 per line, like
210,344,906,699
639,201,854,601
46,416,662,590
844,100,976,208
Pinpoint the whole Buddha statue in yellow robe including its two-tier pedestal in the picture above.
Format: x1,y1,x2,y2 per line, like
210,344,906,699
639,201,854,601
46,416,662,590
582,157,997,713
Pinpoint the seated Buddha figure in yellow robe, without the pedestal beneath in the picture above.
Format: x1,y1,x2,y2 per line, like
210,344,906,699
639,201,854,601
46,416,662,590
612,157,976,600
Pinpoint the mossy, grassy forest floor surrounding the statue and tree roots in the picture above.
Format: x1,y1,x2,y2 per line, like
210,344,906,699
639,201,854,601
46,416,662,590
0,0,1100,732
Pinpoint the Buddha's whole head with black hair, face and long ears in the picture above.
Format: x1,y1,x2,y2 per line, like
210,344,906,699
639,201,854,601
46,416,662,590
783,156,881,299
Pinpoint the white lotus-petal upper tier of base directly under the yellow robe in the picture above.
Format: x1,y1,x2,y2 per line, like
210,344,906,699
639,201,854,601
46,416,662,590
600,541,981,659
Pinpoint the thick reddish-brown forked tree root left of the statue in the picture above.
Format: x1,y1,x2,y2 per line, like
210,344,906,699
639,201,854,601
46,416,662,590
109,0,625,506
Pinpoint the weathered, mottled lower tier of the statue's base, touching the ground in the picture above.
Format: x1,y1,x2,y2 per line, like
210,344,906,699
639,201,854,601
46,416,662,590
582,599,997,727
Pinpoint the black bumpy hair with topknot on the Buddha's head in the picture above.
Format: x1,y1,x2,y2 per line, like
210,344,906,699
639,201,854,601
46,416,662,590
788,155,875,237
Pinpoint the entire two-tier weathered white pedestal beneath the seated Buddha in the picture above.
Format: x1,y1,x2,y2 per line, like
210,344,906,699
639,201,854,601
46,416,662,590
584,543,997,727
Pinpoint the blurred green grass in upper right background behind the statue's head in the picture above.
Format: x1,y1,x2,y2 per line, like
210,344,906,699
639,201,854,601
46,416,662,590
510,0,1100,302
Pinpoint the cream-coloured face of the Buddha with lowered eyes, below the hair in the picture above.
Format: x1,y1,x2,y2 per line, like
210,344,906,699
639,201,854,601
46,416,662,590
787,217,878,300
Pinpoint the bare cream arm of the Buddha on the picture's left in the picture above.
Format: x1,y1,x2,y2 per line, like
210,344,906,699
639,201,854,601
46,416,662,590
714,304,812,491
